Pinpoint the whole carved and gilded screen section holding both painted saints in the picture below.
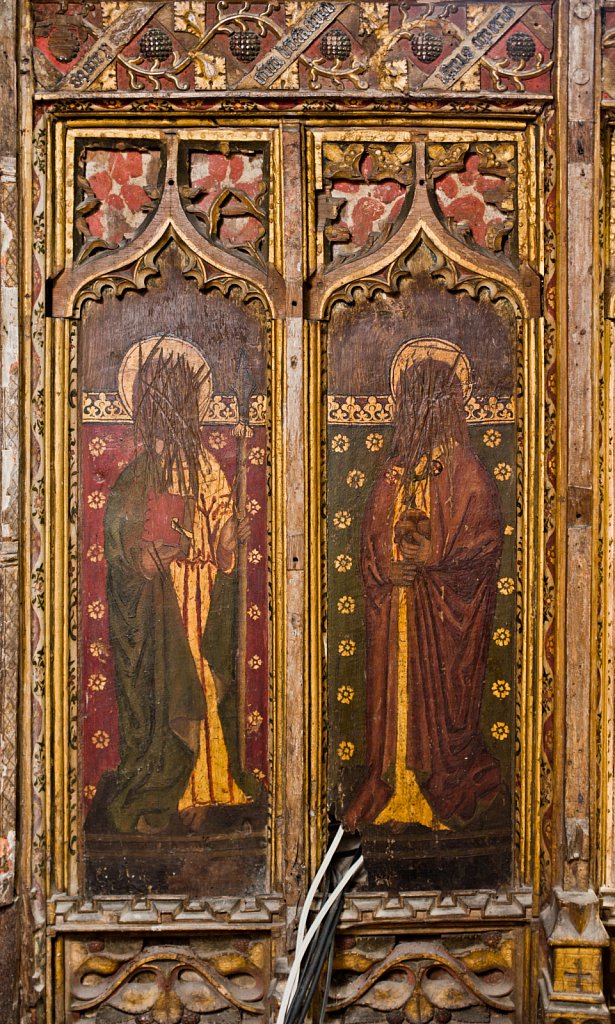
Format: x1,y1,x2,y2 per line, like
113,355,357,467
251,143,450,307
26,0,555,1024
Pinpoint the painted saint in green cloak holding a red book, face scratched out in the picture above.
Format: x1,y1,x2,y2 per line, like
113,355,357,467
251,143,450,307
104,339,253,834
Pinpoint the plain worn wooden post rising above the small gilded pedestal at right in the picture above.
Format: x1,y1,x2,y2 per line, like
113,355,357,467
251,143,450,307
561,0,597,890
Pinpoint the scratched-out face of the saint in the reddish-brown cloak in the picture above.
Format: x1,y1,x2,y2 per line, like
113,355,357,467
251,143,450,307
392,357,469,478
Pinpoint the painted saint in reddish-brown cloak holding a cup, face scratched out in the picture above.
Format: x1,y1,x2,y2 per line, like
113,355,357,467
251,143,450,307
345,342,501,829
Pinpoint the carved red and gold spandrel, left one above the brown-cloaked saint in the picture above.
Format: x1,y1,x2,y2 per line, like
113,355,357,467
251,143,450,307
317,142,415,271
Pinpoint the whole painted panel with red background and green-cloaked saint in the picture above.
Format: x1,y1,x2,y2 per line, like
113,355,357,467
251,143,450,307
78,249,268,894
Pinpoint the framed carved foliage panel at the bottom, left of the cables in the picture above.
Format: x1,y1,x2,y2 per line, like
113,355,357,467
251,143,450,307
56,935,271,1024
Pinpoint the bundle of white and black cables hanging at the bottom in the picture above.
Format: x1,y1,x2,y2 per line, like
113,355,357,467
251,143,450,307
277,825,363,1024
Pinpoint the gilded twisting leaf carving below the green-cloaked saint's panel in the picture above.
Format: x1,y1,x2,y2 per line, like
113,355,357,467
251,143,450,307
71,940,266,1024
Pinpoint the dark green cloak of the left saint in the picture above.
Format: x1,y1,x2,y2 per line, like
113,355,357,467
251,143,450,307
104,456,206,833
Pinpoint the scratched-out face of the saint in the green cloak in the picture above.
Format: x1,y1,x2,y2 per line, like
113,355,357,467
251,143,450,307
133,339,209,497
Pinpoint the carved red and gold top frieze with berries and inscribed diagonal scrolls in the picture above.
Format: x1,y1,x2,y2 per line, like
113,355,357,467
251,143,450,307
34,0,553,94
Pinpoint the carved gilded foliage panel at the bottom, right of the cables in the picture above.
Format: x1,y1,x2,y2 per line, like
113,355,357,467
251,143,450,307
327,933,515,1024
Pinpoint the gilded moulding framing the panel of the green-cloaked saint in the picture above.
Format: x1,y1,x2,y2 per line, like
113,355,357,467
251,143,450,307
45,123,283,913
